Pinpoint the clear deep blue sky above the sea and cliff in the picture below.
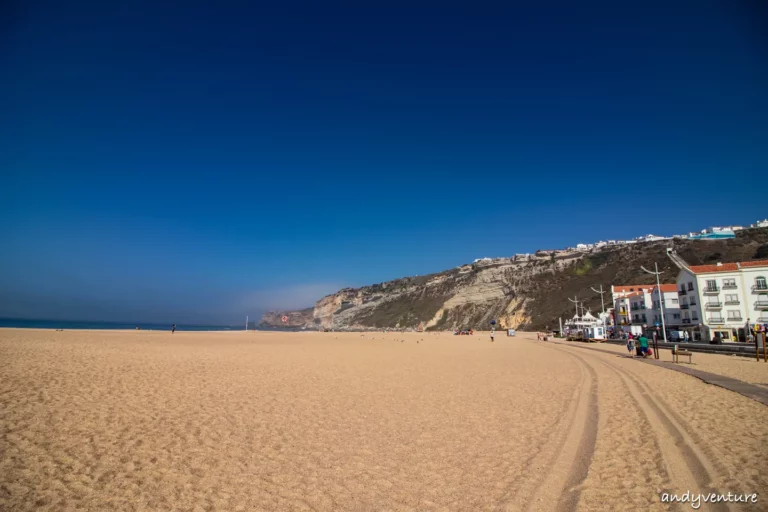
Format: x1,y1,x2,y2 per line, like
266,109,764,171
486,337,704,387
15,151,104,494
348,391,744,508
0,0,768,323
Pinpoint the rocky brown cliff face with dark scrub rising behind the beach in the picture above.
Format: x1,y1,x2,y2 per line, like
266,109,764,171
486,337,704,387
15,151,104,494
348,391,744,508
261,229,768,330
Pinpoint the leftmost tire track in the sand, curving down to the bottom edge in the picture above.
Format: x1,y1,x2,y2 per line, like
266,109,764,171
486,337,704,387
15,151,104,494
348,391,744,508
524,344,599,512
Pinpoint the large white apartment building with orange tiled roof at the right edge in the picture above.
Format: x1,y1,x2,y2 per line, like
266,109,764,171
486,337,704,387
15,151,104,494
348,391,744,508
677,260,768,342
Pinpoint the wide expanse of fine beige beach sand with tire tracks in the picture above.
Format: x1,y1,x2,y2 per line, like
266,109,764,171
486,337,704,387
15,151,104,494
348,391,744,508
0,329,768,511
